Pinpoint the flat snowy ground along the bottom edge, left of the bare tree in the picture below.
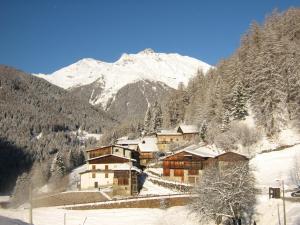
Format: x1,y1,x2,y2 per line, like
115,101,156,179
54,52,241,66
0,206,197,225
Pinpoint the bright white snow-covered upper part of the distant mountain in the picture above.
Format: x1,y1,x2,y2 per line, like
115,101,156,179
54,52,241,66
35,49,211,108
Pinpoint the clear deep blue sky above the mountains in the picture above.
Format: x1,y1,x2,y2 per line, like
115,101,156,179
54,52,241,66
0,0,300,73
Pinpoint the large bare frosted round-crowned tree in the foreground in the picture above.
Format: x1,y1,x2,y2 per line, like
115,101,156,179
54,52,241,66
190,163,256,225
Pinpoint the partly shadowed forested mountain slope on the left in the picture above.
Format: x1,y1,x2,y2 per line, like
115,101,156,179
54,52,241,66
0,66,116,195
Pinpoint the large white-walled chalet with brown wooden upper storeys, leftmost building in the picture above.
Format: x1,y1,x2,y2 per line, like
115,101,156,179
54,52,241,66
80,145,141,195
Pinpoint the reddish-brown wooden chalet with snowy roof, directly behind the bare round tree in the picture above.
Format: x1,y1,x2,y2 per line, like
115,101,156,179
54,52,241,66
163,145,217,184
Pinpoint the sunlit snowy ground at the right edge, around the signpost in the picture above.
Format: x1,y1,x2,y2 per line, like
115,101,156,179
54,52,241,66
250,145,300,225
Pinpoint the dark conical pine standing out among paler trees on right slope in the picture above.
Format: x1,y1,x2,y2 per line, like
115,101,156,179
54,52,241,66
231,81,248,120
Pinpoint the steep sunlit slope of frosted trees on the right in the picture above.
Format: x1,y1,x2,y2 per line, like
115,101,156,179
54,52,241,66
164,8,300,147
